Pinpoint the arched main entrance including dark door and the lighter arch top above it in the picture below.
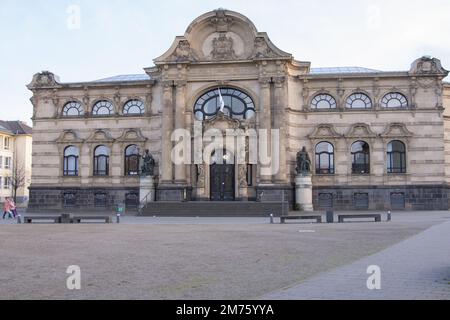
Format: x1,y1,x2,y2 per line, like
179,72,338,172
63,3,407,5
210,151,236,201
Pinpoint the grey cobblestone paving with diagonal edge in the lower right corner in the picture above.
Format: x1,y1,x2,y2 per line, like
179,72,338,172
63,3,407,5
263,222,450,300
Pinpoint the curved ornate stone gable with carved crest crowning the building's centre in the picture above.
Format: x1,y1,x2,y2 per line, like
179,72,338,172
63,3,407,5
155,9,292,64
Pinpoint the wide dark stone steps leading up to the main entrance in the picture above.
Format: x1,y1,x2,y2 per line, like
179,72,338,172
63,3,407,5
140,201,289,217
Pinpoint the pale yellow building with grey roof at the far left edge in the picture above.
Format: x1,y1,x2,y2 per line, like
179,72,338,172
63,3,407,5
0,121,32,205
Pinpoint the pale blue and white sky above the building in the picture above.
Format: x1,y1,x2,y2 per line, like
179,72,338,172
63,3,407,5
0,0,450,125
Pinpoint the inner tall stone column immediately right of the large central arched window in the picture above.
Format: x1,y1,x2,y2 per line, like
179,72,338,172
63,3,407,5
259,78,272,184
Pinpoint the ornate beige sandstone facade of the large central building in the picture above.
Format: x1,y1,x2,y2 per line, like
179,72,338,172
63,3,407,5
28,10,450,210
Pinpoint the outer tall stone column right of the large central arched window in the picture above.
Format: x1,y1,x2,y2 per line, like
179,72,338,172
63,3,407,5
274,77,287,184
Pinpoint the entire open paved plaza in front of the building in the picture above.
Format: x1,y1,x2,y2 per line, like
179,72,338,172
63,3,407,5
0,212,450,299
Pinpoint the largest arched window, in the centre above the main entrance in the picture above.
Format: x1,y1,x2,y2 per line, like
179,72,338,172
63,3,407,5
194,88,255,121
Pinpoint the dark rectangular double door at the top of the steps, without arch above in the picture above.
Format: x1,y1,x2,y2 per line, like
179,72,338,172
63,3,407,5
211,164,235,201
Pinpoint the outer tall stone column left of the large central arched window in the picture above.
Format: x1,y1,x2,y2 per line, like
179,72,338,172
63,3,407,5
160,81,173,184
